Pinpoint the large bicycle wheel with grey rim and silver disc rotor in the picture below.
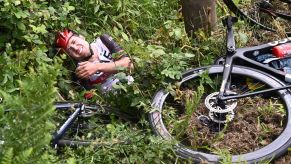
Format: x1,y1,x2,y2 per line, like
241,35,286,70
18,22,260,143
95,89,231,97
149,65,291,163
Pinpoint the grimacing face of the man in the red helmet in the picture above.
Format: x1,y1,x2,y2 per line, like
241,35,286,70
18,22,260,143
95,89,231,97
65,35,90,61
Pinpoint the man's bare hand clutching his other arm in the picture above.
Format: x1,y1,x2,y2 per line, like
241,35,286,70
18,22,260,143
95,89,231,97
76,61,98,79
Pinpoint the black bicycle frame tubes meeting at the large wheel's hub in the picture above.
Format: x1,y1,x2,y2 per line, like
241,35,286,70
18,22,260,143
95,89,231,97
217,17,291,102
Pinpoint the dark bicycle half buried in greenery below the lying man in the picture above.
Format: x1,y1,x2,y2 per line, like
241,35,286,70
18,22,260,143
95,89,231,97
51,102,137,147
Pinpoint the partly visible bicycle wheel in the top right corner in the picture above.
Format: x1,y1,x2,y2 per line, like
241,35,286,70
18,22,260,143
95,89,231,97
223,0,291,35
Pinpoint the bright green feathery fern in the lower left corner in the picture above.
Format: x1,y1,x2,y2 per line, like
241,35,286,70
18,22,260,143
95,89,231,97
0,61,58,163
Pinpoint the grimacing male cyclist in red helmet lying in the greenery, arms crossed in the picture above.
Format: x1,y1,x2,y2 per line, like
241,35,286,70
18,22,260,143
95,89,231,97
56,29,133,98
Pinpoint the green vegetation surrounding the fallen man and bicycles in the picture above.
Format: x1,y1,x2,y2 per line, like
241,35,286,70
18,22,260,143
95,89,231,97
0,0,290,164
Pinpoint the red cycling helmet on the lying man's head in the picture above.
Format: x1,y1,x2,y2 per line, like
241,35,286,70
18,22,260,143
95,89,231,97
56,29,74,49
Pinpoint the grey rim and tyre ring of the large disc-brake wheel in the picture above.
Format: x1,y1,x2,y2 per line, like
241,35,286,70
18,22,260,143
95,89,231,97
149,65,291,163
